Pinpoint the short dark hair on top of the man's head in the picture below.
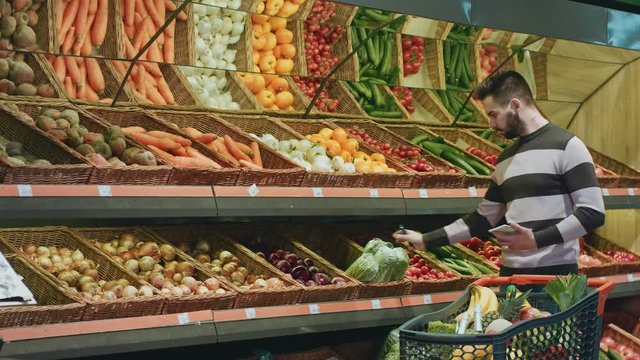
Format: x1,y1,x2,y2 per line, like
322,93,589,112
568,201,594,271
473,70,533,106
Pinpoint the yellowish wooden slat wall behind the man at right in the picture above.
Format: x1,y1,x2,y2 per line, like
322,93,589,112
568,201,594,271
569,57,640,251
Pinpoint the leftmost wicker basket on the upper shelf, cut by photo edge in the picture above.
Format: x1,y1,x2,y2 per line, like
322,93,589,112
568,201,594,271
0,109,92,184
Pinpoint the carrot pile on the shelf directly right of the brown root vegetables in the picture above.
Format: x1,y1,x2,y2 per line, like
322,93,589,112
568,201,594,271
122,126,222,169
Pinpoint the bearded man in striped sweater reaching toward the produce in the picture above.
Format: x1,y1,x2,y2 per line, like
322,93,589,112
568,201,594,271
393,71,604,276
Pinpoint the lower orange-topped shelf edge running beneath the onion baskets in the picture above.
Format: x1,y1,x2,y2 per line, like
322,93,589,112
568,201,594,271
0,273,640,359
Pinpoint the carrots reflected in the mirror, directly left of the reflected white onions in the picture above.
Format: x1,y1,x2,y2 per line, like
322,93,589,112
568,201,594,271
113,0,187,105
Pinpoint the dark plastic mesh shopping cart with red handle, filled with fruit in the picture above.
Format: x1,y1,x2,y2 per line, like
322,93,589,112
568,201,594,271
400,275,615,360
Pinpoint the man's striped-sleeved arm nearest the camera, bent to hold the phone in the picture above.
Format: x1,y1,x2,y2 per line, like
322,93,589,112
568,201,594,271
533,137,604,248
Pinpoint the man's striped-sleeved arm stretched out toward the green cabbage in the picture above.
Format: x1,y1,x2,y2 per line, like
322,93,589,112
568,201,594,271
422,179,506,249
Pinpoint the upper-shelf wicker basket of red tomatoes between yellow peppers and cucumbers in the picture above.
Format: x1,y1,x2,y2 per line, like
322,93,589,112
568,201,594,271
332,120,464,189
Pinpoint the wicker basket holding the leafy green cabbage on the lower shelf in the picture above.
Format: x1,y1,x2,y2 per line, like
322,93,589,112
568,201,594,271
292,228,411,299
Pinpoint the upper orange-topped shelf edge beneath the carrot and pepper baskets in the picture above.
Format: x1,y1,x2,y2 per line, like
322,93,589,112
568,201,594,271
0,185,640,220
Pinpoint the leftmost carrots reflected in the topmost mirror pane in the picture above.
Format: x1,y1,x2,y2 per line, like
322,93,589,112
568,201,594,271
56,0,109,56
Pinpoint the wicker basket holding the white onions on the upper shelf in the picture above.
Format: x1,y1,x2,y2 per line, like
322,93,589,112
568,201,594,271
218,114,364,187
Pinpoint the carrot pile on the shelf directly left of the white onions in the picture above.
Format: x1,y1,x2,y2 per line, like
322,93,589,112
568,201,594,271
181,127,263,170
